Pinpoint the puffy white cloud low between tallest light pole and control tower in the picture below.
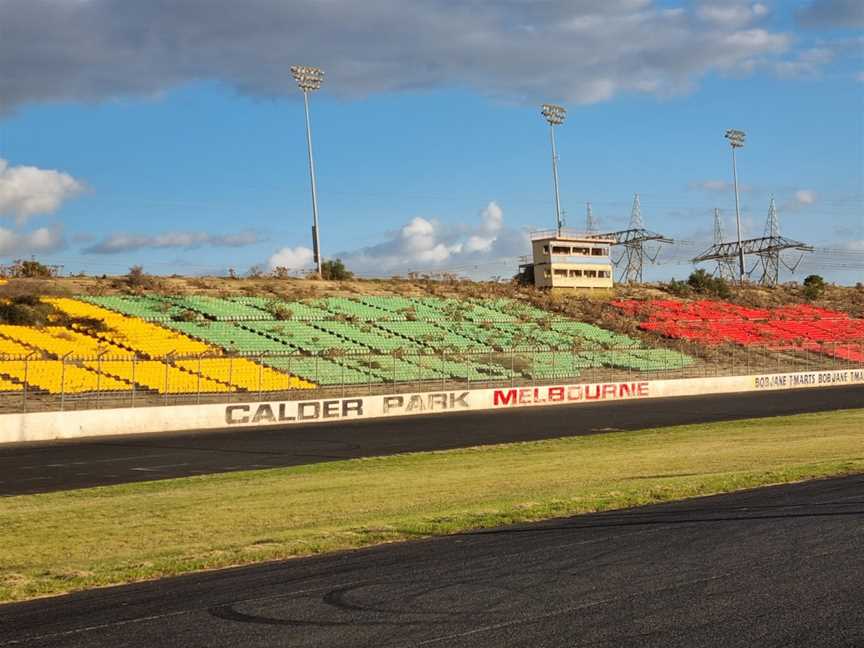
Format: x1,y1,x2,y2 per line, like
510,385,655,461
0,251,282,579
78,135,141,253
334,202,530,276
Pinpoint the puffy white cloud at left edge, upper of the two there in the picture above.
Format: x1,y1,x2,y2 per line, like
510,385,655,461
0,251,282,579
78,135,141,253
0,158,84,225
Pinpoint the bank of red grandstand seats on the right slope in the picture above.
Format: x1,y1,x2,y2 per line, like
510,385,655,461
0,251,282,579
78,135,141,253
613,300,864,362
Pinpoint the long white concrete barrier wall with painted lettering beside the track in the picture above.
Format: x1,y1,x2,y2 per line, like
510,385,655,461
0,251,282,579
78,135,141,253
0,368,864,443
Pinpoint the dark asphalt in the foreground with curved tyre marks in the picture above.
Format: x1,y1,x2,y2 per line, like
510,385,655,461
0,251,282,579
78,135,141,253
0,475,864,648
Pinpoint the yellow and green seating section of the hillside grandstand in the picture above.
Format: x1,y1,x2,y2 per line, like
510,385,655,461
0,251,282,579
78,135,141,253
0,295,693,395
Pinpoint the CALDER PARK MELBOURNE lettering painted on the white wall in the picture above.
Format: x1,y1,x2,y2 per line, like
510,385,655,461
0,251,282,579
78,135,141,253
225,382,649,426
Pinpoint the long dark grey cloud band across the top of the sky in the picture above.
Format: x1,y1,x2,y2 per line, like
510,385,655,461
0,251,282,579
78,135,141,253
0,0,792,113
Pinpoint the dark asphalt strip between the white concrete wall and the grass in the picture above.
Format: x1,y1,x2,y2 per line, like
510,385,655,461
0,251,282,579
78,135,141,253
0,386,864,496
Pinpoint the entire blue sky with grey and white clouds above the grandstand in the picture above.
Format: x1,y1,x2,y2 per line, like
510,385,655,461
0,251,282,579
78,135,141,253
0,0,864,281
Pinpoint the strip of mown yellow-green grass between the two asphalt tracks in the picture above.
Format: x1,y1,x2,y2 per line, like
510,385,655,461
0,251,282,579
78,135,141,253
0,409,864,602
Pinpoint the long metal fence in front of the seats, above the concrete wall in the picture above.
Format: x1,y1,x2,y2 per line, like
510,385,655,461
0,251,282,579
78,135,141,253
0,341,864,413
